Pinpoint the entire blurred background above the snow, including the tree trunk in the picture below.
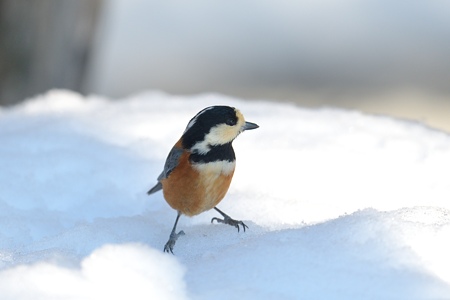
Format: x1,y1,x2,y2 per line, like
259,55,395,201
0,0,450,132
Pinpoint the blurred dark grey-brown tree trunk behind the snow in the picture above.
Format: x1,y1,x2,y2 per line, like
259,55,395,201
0,0,102,105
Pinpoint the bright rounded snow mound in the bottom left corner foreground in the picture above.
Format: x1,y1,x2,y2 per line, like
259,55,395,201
0,245,186,299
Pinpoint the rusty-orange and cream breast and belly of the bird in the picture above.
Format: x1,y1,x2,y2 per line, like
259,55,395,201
161,152,234,216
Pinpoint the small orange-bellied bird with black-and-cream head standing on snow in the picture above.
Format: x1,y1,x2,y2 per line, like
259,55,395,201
147,105,259,254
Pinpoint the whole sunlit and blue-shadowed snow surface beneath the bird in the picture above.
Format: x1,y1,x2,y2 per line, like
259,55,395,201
0,91,450,299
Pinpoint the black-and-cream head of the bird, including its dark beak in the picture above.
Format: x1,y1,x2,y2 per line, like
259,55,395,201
182,106,259,154
